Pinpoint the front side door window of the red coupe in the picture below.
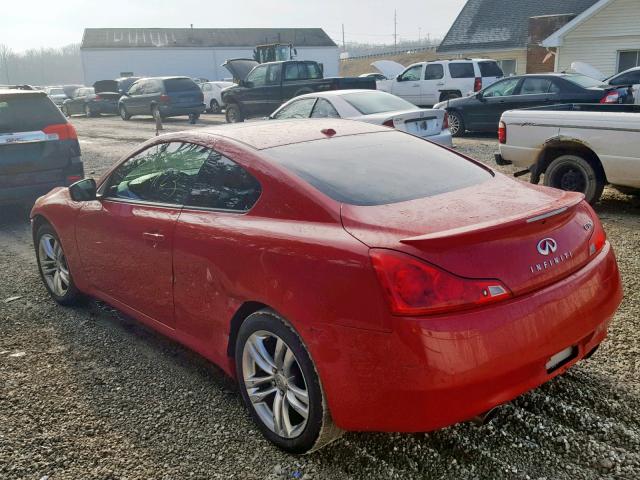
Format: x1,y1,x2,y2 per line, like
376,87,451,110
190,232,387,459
105,142,211,205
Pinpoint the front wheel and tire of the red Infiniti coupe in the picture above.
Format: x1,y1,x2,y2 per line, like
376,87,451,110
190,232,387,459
35,223,81,305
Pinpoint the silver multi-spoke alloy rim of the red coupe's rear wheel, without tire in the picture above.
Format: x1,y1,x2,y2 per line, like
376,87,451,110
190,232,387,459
242,330,309,438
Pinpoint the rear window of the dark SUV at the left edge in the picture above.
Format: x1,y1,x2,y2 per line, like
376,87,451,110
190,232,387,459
0,95,67,133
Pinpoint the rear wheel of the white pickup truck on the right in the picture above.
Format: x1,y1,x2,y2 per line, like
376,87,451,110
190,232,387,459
544,155,604,204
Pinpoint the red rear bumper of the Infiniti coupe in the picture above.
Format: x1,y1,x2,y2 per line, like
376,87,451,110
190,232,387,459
310,244,622,432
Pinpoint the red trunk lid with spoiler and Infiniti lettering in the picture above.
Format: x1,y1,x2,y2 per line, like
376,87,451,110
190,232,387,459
342,175,593,295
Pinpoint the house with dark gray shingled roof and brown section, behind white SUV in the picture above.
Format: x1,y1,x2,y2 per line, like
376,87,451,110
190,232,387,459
437,0,598,74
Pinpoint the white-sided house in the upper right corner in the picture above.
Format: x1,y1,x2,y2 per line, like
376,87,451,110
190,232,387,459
542,0,640,76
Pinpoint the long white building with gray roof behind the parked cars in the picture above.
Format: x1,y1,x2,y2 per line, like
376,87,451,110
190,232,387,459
80,28,339,85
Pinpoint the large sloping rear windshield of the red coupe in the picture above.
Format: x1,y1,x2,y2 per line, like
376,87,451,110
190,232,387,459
266,131,492,206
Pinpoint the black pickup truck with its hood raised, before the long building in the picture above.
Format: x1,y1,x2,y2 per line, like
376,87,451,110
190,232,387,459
222,58,376,123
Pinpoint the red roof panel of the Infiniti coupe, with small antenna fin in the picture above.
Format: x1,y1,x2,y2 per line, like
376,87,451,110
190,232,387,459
195,118,391,150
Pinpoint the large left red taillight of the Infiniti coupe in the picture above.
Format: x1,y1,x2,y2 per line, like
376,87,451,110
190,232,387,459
369,249,511,315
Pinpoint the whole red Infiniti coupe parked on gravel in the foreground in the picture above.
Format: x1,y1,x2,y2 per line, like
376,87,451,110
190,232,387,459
32,119,622,453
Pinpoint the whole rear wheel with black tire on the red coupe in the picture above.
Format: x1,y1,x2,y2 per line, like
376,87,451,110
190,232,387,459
235,310,342,453
